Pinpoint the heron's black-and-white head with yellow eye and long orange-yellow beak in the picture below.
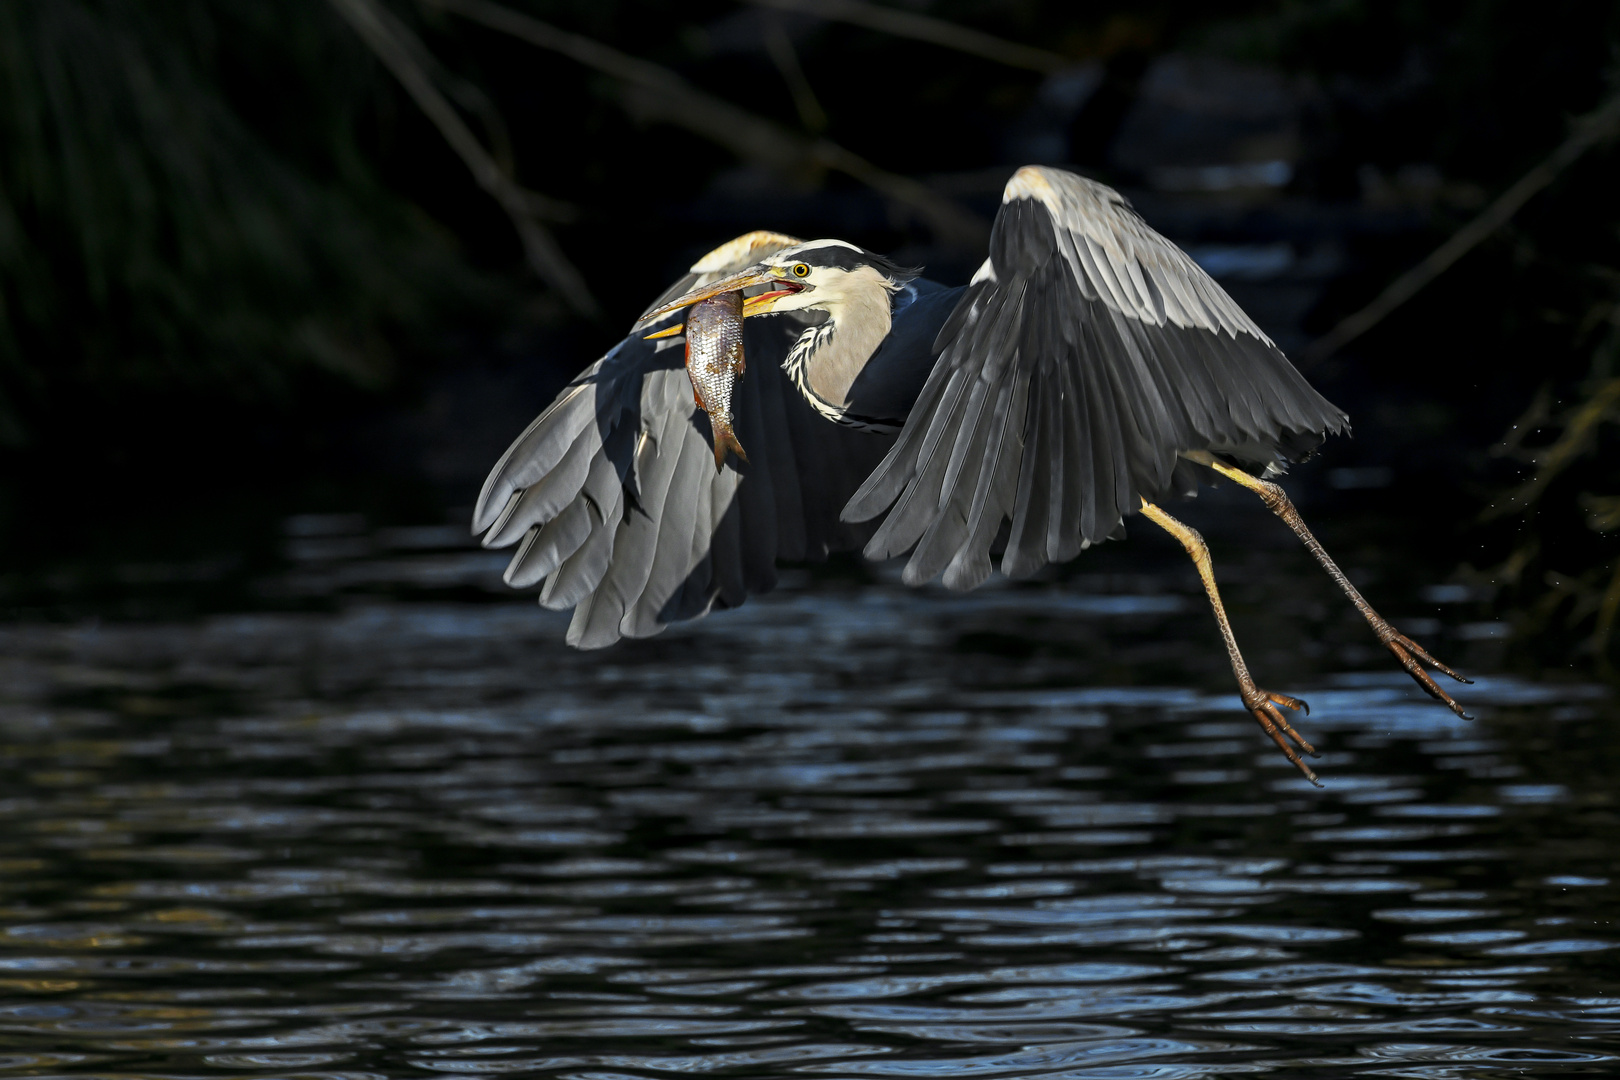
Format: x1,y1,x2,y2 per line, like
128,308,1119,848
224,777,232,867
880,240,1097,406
638,240,915,334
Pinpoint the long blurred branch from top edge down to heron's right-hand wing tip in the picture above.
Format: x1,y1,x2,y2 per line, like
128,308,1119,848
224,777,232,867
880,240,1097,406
424,0,990,248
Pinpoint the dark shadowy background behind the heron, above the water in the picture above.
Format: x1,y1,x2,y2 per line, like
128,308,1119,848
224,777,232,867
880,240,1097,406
0,0,1620,667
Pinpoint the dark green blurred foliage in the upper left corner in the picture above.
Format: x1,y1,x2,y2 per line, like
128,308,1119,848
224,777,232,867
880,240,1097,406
0,0,492,444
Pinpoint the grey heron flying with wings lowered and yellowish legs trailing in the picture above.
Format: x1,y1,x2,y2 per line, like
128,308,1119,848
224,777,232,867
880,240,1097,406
473,165,1469,784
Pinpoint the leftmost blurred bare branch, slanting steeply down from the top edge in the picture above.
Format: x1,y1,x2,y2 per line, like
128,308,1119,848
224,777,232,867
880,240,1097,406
330,0,598,317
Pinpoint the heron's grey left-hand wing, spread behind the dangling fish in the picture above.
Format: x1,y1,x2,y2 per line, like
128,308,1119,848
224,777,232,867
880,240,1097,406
473,231,893,648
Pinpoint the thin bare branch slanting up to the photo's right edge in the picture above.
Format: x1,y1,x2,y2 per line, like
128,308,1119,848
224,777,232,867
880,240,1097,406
1299,89,1620,366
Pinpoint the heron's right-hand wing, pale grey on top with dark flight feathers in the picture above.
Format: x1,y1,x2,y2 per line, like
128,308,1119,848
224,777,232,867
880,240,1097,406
844,167,1346,588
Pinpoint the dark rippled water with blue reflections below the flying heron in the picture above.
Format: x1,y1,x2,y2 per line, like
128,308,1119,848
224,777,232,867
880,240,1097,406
0,554,1620,1080
